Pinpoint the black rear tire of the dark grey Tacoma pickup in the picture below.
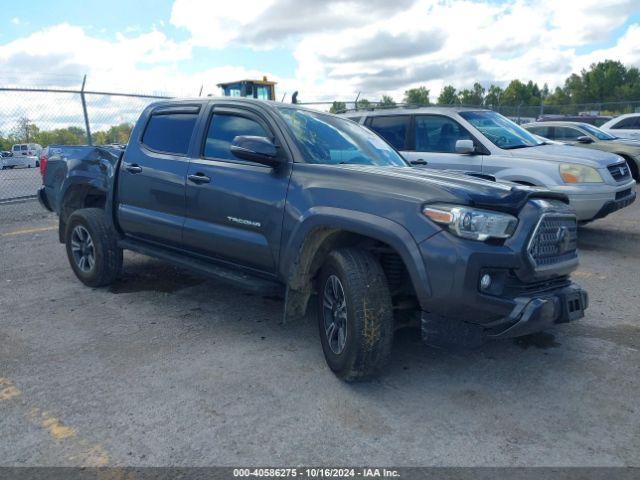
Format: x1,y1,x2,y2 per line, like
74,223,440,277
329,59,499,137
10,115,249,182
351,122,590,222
65,208,122,287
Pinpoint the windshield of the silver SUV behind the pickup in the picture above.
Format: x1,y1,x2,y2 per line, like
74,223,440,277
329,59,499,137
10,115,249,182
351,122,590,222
460,111,544,150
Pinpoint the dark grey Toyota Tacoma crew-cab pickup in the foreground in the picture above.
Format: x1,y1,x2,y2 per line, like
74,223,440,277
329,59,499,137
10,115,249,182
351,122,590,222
38,98,588,380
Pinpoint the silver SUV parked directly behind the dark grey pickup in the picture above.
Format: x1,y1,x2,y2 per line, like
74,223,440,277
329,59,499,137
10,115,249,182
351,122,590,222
346,107,636,222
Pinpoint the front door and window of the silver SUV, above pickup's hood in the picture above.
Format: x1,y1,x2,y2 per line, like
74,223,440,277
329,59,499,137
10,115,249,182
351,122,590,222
403,115,482,172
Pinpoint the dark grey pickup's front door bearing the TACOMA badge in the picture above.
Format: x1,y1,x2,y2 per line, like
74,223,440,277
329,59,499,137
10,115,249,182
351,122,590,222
184,105,291,274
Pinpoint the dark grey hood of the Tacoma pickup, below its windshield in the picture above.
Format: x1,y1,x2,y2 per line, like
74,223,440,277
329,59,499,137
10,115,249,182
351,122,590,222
342,165,569,214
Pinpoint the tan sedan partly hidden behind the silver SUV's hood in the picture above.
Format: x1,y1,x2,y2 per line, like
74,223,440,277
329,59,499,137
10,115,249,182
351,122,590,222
523,122,640,182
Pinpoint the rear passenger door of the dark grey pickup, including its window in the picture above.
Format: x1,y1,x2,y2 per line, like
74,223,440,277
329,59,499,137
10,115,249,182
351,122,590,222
117,105,200,247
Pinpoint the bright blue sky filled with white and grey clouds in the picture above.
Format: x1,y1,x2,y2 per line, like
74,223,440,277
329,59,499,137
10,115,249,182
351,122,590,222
0,0,640,101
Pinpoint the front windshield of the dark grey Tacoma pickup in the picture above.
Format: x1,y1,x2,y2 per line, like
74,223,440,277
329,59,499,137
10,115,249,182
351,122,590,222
278,107,408,167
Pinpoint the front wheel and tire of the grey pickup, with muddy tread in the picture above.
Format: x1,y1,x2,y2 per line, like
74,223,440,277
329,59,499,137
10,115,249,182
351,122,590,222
317,248,393,381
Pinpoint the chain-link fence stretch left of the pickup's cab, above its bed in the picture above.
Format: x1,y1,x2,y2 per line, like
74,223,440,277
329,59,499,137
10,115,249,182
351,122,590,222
0,87,168,212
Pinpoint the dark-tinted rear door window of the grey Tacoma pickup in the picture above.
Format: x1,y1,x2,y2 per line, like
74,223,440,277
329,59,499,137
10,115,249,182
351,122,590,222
142,113,198,155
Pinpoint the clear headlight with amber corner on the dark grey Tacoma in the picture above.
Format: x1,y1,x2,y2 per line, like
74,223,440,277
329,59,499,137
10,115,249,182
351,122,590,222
422,205,518,241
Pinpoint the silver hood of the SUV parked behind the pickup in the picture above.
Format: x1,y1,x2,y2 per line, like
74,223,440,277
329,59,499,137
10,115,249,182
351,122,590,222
507,145,619,168
